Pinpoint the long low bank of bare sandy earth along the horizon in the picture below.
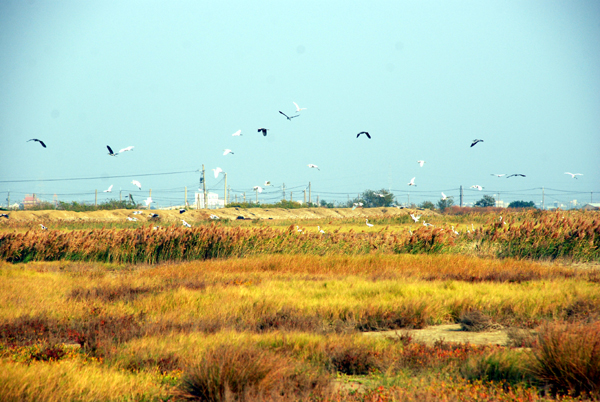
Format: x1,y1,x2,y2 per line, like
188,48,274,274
0,208,437,223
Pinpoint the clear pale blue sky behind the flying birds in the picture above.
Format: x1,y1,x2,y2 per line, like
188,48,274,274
0,0,600,205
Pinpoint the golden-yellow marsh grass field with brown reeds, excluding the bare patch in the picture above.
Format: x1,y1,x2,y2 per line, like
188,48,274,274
0,212,600,401
